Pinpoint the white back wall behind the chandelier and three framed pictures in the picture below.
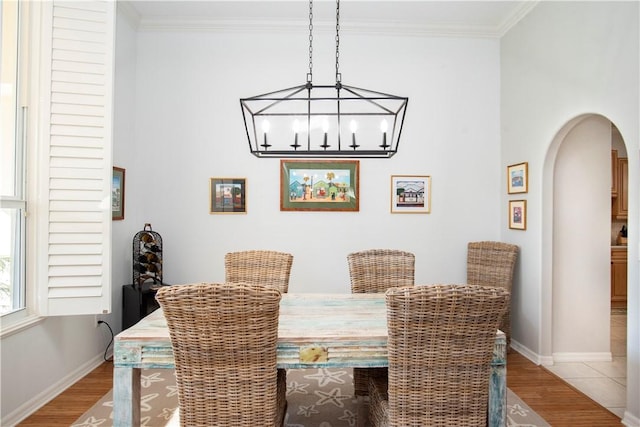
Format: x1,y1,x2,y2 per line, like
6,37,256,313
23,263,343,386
129,29,503,292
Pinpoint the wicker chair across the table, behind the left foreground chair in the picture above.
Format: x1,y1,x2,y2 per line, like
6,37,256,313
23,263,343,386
224,250,293,293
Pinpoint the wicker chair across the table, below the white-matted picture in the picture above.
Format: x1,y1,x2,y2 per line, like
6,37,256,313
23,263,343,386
347,249,415,396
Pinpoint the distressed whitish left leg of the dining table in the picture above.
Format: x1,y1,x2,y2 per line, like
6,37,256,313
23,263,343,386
113,367,141,427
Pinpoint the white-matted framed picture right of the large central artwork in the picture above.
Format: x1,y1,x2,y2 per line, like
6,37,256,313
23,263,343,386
391,175,431,213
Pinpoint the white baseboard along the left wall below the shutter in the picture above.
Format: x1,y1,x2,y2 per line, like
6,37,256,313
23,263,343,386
2,353,104,426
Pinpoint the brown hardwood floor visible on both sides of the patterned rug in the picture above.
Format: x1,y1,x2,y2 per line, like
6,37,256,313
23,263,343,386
19,352,622,427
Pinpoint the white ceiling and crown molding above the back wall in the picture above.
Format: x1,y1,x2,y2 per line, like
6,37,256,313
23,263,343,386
119,0,537,36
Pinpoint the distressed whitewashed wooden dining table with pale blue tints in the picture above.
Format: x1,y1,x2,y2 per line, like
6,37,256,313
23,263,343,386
113,293,507,427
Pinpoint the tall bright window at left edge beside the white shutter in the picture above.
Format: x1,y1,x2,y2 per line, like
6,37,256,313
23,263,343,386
0,1,26,315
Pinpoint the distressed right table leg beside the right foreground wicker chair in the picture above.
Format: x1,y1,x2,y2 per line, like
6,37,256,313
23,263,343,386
489,336,507,427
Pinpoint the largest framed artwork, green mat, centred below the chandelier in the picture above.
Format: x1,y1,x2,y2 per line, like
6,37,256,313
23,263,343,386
280,160,360,211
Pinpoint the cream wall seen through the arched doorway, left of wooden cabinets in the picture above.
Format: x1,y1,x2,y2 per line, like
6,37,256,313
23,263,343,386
541,114,626,414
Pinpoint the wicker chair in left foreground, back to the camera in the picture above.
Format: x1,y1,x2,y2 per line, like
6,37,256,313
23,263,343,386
156,283,287,427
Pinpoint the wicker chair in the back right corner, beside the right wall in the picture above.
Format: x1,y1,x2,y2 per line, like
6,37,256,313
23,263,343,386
467,241,518,350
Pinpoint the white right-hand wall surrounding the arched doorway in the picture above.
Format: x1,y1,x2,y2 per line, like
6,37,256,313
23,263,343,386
501,2,640,425
